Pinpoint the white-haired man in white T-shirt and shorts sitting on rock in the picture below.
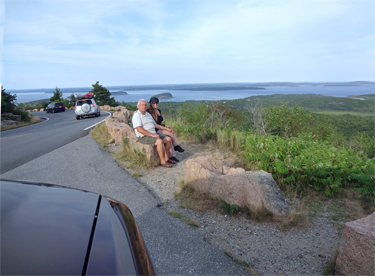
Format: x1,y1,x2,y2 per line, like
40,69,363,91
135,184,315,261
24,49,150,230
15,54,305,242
132,99,176,168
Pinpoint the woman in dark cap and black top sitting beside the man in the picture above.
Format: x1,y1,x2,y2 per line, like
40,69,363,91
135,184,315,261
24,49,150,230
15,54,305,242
147,97,185,162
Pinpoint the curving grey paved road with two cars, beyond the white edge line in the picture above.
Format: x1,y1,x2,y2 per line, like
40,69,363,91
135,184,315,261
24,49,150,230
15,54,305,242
0,110,110,173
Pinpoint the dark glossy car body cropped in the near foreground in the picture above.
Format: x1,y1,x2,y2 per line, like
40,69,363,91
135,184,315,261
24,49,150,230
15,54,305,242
0,180,155,275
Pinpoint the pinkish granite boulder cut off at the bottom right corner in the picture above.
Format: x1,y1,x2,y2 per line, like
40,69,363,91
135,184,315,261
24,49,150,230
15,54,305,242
336,212,375,276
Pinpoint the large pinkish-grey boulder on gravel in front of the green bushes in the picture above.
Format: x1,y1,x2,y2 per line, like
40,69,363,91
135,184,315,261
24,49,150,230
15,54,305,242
185,156,292,216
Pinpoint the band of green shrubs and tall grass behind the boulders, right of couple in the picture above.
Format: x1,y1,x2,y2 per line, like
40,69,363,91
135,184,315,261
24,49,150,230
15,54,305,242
163,101,375,211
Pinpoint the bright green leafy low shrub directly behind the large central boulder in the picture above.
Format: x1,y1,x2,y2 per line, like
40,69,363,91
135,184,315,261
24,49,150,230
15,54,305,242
245,134,375,203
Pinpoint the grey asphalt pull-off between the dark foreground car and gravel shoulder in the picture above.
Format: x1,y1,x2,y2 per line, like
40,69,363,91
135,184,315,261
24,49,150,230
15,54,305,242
1,135,253,275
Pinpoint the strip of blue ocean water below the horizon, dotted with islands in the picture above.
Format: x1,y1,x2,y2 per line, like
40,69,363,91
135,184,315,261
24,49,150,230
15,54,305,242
12,86,375,103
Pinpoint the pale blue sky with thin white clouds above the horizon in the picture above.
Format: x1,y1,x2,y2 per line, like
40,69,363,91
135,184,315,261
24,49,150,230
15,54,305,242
0,0,375,89
